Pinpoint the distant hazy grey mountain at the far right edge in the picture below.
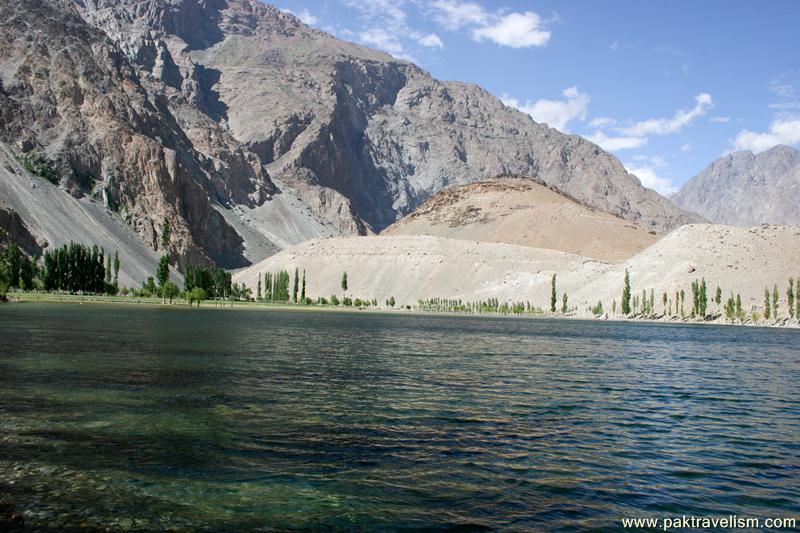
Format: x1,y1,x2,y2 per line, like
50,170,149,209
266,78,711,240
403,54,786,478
672,145,800,226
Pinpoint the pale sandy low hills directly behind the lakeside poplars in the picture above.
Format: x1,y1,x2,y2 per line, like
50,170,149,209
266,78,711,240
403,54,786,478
234,224,800,317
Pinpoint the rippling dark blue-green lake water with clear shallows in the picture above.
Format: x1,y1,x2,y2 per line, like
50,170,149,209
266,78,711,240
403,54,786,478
0,304,800,531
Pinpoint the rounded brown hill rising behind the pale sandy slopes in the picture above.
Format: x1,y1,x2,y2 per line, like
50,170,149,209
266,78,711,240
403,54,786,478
381,177,658,261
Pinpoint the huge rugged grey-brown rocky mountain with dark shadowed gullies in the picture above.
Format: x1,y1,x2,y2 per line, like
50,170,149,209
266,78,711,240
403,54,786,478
0,0,694,280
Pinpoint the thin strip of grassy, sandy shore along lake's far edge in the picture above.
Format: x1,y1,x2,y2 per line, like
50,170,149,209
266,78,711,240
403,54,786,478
0,292,800,330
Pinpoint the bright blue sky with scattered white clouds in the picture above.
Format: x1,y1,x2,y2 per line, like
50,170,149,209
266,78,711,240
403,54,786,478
277,0,800,194
